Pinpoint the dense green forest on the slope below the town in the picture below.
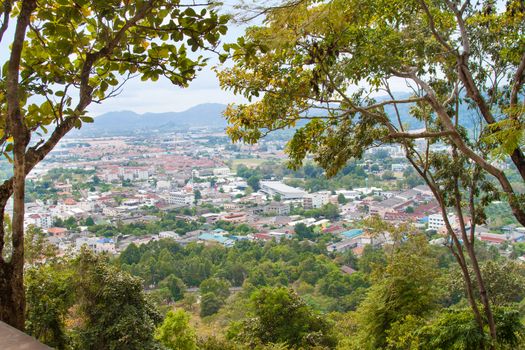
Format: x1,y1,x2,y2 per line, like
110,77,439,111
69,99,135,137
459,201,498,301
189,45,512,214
22,222,525,349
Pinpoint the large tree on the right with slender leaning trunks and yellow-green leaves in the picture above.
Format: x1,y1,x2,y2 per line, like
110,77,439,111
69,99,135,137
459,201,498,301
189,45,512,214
219,0,525,344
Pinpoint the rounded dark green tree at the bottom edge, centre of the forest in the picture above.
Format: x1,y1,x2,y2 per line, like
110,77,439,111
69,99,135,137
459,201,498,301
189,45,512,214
229,287,336,349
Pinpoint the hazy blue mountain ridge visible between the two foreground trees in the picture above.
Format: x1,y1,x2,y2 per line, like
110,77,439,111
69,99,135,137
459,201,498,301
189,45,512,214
73,103,226,136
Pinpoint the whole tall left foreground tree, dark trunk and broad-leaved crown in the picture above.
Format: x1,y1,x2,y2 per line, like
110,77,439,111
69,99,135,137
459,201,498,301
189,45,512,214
0,0,227,329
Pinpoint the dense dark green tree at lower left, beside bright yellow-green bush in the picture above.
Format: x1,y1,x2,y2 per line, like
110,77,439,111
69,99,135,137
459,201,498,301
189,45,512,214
73,250,161,350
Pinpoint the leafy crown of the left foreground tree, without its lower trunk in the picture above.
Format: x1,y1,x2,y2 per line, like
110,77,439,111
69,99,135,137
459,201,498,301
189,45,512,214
0,0,228,164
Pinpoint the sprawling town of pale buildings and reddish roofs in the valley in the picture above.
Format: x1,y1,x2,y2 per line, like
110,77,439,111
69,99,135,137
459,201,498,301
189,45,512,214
17,128,525,259
